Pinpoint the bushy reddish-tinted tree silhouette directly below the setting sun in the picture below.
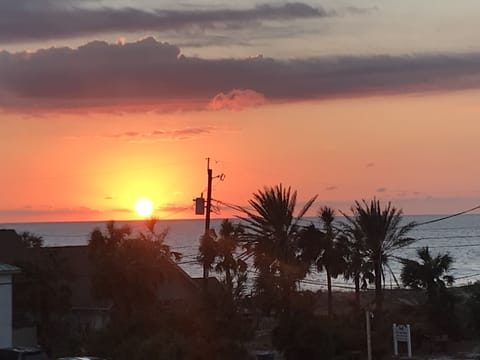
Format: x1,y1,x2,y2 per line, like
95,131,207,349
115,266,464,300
88,221,180,323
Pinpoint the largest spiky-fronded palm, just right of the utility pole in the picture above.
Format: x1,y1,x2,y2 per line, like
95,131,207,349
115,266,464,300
244,184,316,310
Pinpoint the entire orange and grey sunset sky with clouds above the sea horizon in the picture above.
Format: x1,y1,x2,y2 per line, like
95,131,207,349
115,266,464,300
0,0,480,223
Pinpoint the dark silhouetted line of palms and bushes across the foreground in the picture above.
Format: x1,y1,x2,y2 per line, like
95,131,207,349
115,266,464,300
12,185,480,360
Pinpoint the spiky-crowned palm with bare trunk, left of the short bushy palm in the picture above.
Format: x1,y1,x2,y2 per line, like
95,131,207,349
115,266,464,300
343,199,415,314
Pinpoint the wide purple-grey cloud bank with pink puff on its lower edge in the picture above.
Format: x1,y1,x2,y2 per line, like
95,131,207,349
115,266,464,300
0,38,480,110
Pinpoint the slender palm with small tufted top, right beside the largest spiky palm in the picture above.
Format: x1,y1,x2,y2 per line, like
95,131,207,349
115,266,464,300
300,206,346,317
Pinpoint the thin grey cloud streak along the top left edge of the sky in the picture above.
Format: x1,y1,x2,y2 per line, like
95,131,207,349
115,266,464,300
0,0,326,43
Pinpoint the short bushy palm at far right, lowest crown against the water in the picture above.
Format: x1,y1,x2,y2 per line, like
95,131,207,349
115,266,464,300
400,246,454,304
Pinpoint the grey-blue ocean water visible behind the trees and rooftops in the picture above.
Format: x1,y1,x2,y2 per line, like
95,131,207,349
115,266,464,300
0,214,480,289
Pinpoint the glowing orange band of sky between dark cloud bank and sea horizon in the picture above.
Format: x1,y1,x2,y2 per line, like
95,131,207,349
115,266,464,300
0,91,480,222
